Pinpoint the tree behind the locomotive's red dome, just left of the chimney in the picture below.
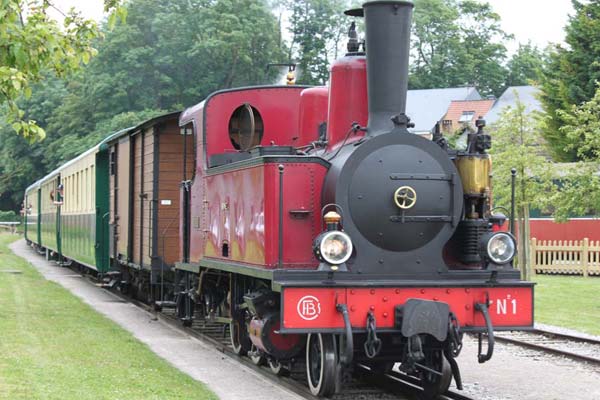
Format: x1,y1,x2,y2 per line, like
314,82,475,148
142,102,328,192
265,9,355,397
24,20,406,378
288,0,349,85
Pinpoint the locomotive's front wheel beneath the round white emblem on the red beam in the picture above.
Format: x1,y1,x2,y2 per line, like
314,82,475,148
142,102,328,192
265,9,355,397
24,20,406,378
306,333,338,397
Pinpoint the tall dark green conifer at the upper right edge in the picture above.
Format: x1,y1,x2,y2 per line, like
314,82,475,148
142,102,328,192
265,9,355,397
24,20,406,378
540,0,600,161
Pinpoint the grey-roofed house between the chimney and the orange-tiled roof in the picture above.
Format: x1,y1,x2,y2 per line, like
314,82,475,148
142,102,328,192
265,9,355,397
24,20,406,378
406,86,481,136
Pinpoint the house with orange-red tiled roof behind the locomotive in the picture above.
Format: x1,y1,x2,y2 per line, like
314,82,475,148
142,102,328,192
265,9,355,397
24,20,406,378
440,99,496,134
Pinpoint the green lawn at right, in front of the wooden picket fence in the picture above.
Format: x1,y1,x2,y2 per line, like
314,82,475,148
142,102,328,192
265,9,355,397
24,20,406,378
533,275,600,335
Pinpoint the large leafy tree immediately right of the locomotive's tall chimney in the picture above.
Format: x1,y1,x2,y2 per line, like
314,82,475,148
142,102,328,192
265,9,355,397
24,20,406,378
409,0,510,96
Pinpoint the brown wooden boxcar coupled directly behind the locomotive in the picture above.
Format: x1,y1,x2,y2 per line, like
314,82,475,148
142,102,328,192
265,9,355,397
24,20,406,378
108,112,194,294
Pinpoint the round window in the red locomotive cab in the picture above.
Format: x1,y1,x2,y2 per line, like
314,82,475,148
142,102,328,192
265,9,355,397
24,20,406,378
229,104,264,151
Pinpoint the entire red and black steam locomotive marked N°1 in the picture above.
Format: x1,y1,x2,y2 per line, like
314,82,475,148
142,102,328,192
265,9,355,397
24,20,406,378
174,1,533,397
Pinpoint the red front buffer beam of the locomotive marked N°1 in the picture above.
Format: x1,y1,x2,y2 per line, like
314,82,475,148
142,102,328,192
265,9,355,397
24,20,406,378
282,286,533,333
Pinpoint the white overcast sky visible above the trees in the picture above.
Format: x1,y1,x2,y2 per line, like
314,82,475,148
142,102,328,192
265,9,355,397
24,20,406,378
53,0,573,52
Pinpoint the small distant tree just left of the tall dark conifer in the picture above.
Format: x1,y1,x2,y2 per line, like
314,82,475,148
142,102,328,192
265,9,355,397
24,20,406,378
506,43,544,87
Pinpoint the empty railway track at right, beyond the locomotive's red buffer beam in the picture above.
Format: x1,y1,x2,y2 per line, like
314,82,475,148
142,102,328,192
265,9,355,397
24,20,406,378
495,329,600,366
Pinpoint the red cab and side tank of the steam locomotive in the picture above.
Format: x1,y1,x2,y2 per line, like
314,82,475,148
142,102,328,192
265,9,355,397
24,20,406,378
181,87,328,269
